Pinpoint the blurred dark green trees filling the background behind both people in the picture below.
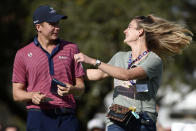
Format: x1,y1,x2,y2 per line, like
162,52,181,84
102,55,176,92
0,0,196,130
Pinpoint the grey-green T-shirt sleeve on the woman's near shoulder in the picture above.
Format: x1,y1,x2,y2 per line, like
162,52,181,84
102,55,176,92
138,54,163,79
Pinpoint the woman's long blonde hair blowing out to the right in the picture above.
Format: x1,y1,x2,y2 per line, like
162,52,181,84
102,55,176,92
134,15,193,58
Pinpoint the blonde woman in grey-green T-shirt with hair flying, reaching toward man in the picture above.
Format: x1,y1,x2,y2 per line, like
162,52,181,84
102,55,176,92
74,15,193,131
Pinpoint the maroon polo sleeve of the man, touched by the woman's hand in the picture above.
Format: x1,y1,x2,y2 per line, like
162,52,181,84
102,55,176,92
74,47,85,77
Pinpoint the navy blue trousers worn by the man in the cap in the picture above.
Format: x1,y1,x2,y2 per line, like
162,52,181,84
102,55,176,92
27,110,79,131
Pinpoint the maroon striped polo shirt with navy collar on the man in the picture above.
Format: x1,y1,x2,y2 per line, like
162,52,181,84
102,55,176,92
12,40,85,109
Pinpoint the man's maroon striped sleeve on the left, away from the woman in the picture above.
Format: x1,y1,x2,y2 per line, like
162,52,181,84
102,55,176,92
12,52,27,84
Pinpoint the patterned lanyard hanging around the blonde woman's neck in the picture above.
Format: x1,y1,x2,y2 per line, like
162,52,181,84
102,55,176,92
128,50,150,86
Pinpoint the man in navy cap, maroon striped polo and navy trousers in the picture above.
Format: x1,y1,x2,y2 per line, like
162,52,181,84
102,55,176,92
12,5,85,131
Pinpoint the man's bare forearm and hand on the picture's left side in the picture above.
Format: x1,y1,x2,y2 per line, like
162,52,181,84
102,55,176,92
12,83,45,105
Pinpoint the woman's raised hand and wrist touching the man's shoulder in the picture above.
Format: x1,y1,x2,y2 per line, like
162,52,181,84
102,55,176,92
74,53,96,65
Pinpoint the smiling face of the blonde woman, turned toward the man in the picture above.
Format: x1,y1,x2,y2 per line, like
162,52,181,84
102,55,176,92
124,20,140,43
